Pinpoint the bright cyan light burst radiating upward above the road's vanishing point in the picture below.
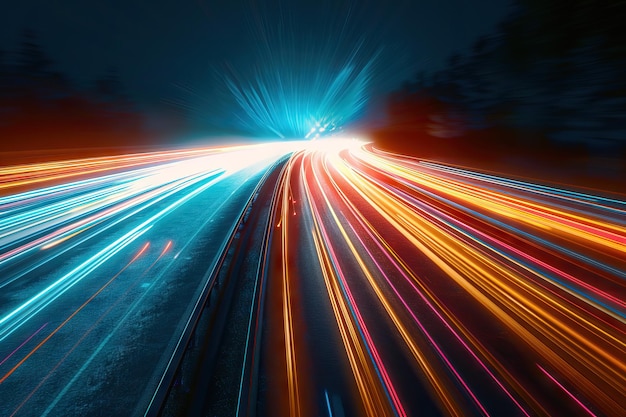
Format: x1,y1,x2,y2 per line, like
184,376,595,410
224,2,381,138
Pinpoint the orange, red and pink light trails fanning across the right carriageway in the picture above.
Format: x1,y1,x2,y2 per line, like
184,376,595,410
279,141,626,415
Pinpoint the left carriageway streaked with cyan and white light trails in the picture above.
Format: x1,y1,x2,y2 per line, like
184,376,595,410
0,143,294,415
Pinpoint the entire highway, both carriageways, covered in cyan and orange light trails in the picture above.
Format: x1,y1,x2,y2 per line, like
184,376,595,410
0,139,626,416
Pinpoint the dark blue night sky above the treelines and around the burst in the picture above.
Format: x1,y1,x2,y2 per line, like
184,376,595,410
0,0,510,127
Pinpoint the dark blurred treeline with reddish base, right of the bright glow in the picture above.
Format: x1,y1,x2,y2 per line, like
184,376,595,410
378,0,626,184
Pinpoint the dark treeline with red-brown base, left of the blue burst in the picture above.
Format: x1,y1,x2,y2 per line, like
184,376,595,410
0,30,146,151
